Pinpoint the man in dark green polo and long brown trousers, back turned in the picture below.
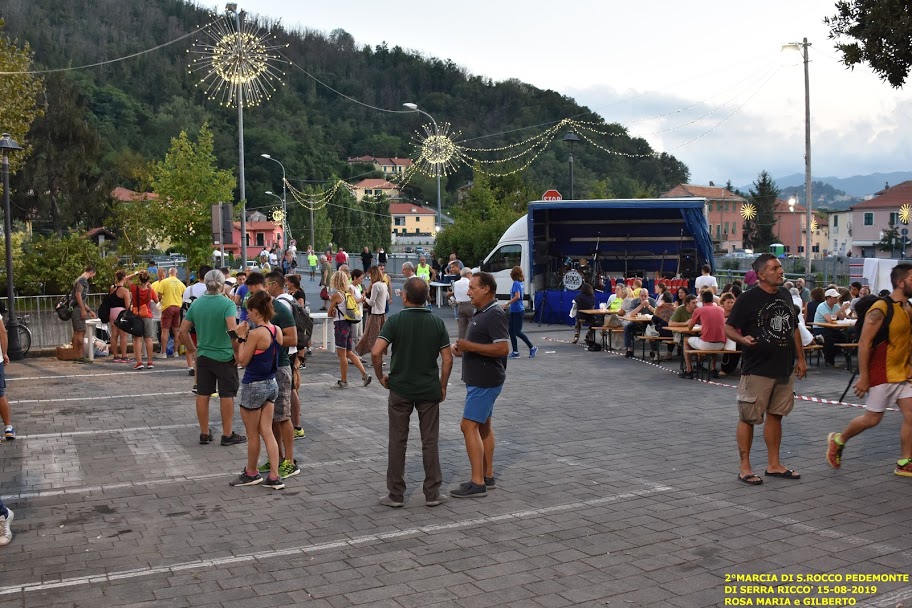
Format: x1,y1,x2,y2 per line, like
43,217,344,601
371,276,453,508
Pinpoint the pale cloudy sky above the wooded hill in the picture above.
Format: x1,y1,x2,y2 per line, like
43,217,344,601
207,0,912,186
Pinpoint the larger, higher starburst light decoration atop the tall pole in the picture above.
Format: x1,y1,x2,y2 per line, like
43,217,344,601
187,17,288,106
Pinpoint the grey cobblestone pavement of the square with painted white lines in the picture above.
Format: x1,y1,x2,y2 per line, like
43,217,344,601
0,309,912,608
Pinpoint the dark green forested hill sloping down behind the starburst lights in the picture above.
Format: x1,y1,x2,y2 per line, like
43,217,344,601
2,0,688,238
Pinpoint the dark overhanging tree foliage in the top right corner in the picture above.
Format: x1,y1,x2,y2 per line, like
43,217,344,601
824,0,912,89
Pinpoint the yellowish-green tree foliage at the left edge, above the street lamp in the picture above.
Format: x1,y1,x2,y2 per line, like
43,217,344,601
0,19,44,173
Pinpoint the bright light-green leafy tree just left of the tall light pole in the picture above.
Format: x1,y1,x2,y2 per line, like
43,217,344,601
150,124,235,268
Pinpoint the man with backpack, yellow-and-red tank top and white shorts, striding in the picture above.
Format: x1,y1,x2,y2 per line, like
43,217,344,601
826,263,912,477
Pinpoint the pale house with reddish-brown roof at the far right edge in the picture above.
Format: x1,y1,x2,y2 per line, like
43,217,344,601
849,181,912,258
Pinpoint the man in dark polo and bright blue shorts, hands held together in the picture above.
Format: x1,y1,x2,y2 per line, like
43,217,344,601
450,272,510,498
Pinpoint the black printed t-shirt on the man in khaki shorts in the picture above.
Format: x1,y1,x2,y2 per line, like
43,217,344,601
726,287,798,378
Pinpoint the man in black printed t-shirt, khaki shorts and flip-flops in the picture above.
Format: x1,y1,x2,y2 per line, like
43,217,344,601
725,253,807,485
